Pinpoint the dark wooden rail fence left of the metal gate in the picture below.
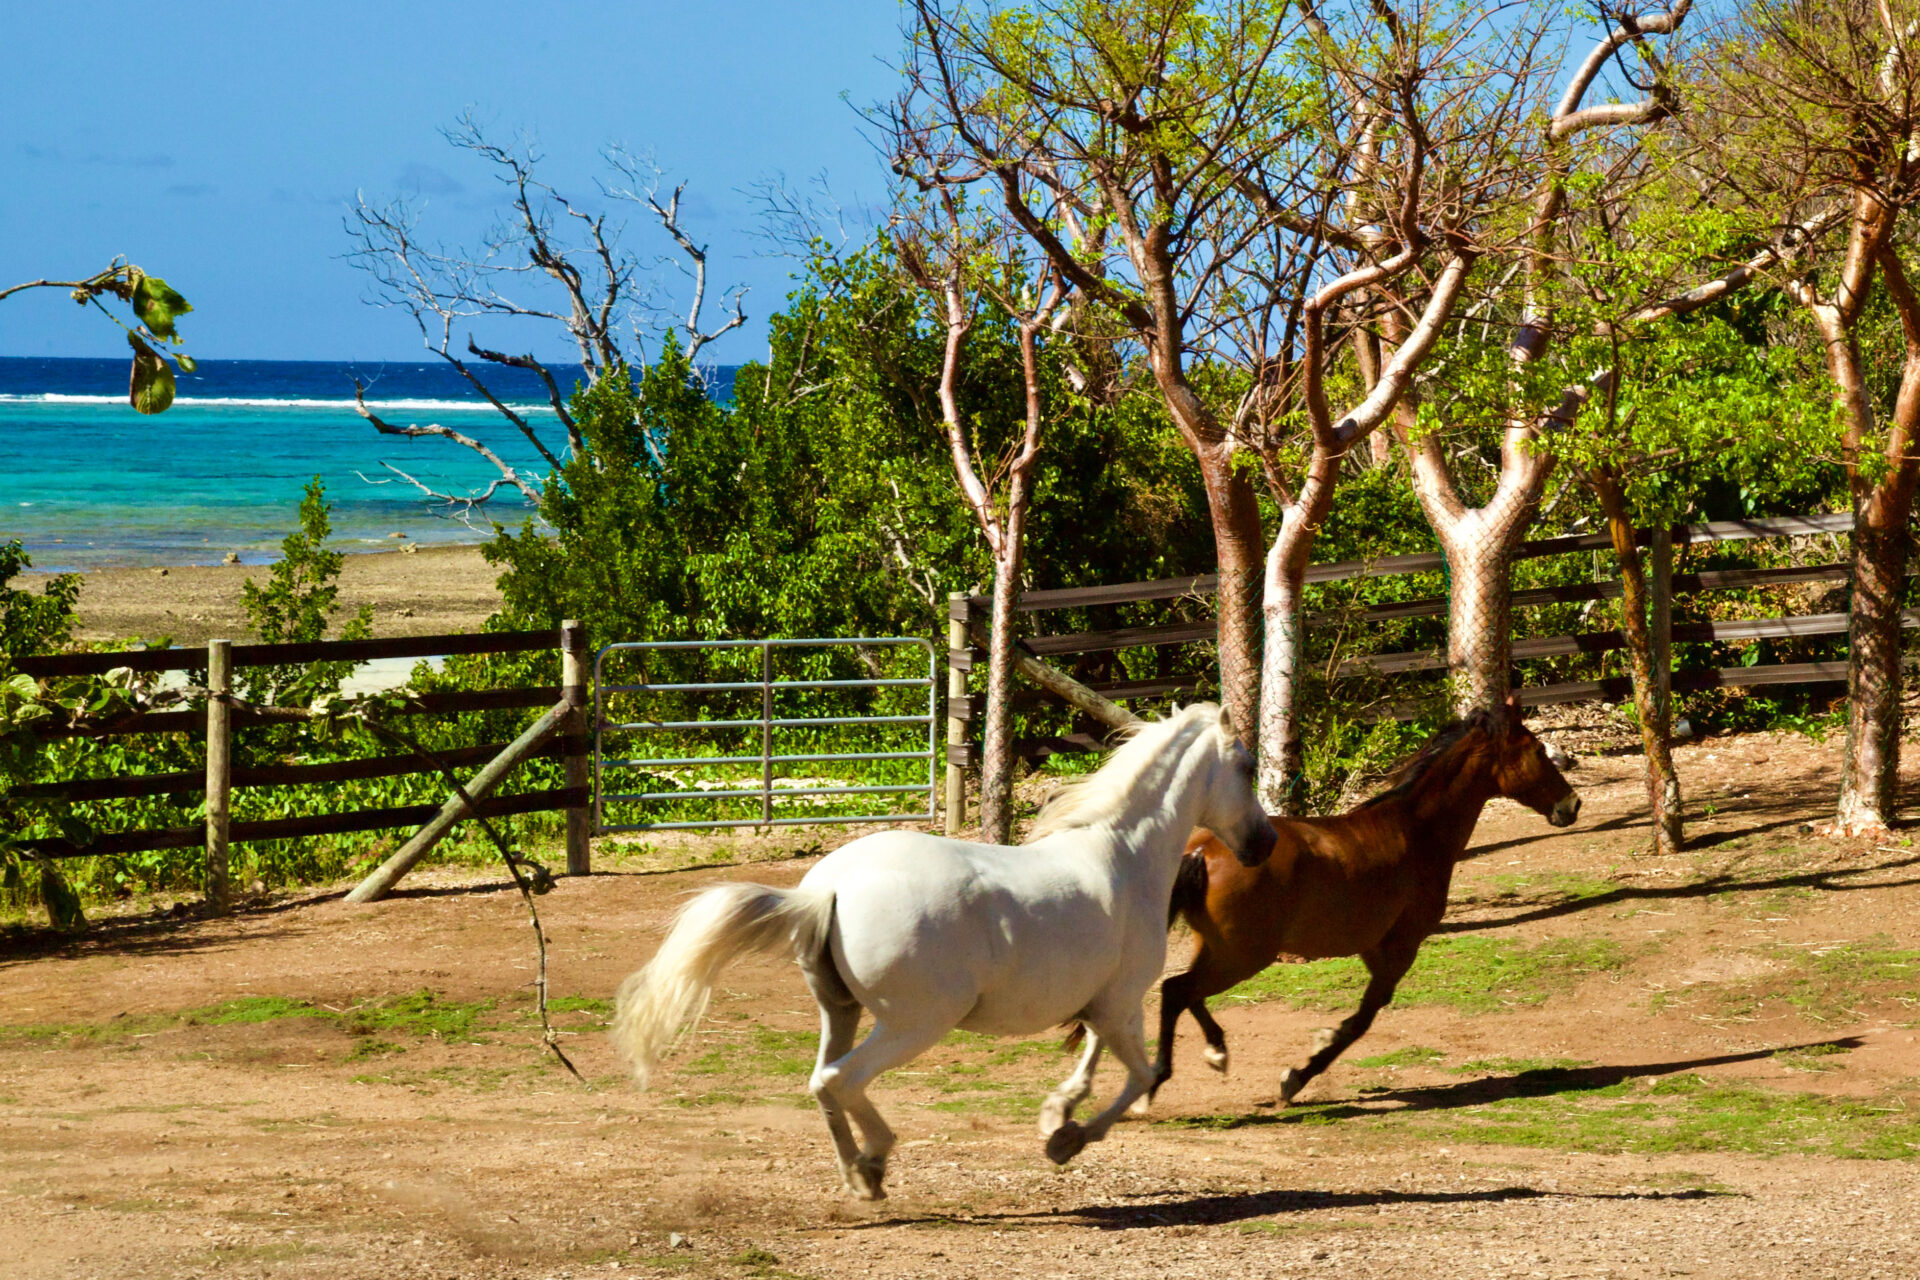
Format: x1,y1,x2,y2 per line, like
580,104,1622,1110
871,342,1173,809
13,624,591,906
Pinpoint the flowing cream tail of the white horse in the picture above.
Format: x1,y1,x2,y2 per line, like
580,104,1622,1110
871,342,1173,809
611,885,833,1088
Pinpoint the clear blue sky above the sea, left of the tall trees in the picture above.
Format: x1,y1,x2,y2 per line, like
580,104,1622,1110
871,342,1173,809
0,0,900,363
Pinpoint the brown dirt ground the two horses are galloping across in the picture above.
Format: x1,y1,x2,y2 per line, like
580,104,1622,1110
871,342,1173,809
0,725,1920,1280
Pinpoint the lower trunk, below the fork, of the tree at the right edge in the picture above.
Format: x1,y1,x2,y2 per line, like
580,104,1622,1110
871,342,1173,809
1836,498,1910,835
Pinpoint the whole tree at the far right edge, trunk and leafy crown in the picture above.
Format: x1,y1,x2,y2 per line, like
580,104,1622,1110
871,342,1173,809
1695,0,1920,833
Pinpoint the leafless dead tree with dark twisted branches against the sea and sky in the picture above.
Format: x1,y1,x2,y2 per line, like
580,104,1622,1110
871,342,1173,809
346,115,747,510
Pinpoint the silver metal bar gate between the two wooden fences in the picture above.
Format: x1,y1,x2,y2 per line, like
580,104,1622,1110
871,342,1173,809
593,635,939,835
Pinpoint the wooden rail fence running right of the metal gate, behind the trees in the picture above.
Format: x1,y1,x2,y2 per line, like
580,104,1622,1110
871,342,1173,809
947,512,1881,770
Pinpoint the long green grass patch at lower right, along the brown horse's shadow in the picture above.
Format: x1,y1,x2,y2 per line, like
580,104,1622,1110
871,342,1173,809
1164,1067,1920,1159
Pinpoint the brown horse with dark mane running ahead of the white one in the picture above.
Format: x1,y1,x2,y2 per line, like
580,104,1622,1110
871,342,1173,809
1154,699,1580,1103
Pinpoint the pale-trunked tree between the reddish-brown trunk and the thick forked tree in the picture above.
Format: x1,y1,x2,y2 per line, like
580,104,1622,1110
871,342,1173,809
1236,4,1540,812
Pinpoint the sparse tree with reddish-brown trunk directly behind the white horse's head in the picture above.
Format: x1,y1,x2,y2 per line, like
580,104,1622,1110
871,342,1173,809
897,0,1300,741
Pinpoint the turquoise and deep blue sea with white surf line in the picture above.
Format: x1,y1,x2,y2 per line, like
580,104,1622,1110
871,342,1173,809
0,357,732,570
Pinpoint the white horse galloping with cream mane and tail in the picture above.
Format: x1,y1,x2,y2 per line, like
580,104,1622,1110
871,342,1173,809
612,702,1275,1199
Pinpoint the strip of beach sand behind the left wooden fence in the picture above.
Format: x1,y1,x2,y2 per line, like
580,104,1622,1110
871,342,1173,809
15,547,499,645
